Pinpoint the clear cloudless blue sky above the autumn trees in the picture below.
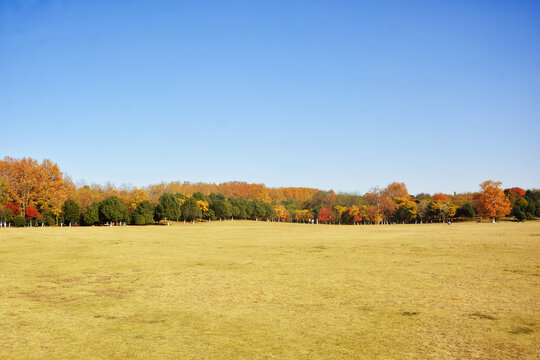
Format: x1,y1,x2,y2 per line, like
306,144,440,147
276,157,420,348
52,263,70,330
0,0,540,193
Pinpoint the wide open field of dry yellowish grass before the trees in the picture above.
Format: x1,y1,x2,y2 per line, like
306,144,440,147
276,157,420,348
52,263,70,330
0,221,540,359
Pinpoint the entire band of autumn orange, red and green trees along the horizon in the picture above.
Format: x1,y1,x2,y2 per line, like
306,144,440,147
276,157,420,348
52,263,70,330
0,157,540,226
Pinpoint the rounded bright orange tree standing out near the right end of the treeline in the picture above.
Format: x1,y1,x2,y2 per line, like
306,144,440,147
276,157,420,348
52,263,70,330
474,180,512,222
